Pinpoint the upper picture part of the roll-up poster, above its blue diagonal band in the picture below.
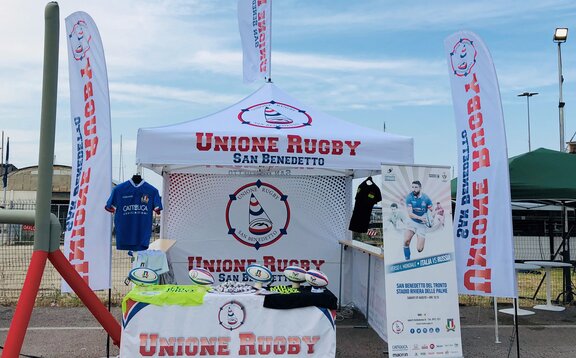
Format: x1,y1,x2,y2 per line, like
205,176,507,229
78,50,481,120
382,166,451,261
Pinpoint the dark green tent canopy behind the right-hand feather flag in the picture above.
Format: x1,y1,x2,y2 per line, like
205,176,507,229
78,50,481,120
451,148,576,206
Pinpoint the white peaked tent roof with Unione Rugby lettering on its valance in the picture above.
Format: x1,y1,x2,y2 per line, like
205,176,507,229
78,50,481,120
136,83,414,173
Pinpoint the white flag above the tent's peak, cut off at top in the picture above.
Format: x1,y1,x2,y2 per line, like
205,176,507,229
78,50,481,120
238,0,272,82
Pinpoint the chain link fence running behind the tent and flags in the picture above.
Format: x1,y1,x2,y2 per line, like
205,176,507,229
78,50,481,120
0,201,576,306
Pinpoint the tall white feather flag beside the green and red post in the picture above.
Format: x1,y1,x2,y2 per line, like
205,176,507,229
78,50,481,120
62,11,112,292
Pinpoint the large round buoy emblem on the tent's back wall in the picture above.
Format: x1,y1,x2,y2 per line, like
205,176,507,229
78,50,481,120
226,180,290,250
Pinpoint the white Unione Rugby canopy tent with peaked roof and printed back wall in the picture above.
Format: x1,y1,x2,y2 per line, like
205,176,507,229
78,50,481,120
136,83,414,337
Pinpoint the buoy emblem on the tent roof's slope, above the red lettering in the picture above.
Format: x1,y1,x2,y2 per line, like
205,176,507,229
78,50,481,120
238,101,312,129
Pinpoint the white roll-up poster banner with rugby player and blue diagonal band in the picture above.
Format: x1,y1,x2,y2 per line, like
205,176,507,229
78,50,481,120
382,164,462,357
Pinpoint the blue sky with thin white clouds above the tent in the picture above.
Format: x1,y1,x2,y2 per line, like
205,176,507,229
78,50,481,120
0,0,576,189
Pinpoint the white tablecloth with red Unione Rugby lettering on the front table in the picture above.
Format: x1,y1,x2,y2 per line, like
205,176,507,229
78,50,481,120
120,293,336,357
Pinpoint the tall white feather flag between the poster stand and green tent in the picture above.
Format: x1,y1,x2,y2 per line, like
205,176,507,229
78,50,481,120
444,31,517,297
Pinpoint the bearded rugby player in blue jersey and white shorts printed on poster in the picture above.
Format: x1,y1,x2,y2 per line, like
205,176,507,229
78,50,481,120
404,180,432,260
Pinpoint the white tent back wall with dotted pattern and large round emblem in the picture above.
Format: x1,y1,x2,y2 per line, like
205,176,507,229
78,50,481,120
162,173,351,294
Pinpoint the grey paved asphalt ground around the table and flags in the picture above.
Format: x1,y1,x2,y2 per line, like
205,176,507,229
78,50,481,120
0,306,576,358
